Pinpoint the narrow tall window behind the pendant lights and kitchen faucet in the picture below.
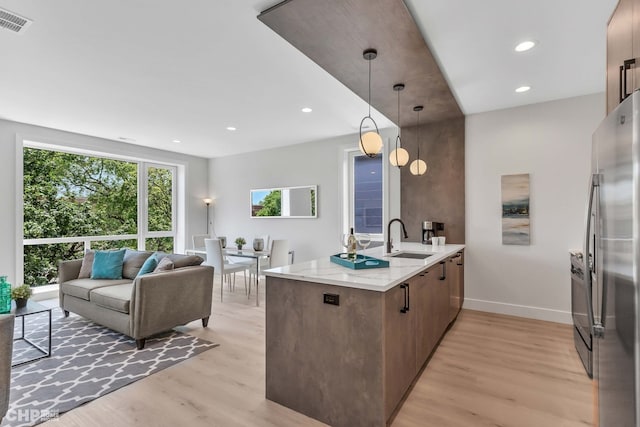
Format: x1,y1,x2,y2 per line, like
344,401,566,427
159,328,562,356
344,150,384,240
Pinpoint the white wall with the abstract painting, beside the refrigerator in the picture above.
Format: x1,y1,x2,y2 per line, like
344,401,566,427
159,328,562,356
465,94,605,323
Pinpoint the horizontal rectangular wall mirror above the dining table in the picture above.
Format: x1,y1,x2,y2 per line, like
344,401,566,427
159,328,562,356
250,185,318,218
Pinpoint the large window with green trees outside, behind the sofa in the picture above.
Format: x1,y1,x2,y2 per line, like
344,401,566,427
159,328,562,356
23,144,176,286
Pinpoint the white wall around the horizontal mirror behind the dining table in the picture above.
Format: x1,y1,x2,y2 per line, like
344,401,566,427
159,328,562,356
209,128,400,262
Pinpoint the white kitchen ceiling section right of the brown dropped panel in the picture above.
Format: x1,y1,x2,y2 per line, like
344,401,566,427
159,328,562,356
405,0,618,114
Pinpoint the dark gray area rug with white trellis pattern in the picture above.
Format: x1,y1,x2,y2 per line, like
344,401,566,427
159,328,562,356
0,308,218,427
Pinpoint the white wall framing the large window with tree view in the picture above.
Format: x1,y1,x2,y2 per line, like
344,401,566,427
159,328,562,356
0,120,209,283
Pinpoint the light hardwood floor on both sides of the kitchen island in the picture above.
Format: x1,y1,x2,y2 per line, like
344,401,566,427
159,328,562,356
42,277,592,427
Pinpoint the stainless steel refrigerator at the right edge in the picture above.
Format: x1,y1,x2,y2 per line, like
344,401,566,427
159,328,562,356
584,92,640,427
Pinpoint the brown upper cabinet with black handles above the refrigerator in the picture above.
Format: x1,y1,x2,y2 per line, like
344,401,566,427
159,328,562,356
607,0,640,113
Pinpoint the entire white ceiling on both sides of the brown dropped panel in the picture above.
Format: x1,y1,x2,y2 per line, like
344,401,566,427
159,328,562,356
0,0,617,157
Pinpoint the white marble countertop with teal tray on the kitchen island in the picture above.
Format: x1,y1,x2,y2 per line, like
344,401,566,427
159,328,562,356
265,242,464,292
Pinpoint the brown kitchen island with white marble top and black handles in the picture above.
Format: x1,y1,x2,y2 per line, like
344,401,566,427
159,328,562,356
266,242,464,427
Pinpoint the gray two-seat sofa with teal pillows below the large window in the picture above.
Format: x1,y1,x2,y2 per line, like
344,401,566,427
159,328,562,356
58,250,213,349
